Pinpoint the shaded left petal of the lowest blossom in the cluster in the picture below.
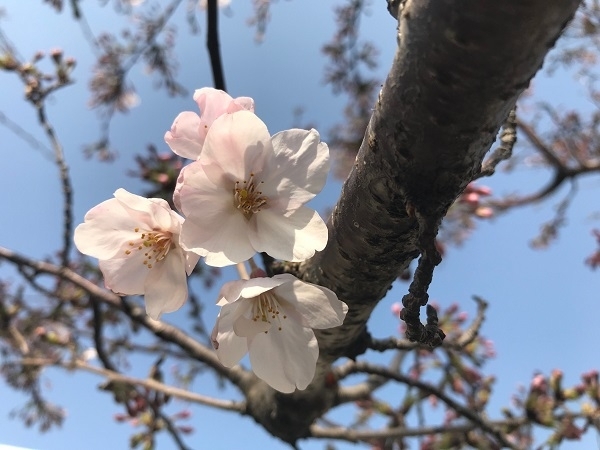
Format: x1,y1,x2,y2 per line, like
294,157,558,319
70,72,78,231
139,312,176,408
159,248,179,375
211,303,248,367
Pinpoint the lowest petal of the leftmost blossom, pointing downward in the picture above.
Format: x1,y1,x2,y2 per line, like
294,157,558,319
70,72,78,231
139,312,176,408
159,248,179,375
144,248,188,319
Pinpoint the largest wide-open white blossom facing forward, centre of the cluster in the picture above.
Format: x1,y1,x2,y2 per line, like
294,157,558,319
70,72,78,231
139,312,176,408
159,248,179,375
174,111,329,267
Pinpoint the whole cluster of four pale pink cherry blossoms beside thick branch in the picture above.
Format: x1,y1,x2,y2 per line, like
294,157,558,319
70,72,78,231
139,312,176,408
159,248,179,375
75,88,348,392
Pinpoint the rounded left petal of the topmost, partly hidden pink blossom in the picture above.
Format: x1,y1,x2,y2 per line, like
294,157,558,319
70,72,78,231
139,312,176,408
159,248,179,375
165,111,206,160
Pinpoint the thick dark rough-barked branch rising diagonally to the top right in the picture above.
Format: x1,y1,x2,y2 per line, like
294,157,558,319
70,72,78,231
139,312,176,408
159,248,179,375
246,0,579,443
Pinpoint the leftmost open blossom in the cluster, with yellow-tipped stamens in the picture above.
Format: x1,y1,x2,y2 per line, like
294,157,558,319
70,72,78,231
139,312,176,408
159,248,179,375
75,189,199,319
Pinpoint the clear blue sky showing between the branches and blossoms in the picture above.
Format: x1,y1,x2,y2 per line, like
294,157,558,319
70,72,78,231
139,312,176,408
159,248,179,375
0,0,600,450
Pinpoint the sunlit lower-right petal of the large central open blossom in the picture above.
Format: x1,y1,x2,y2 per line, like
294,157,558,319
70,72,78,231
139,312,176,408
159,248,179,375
249,206,328,261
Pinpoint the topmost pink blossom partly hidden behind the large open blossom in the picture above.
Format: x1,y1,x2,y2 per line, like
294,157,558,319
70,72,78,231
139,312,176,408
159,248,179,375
165,88,254,159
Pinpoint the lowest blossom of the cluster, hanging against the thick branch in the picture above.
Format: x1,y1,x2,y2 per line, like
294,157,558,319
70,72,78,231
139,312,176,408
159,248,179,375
211,274,348,393
